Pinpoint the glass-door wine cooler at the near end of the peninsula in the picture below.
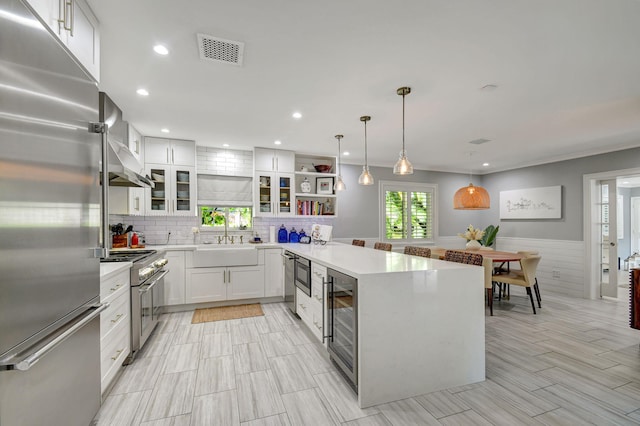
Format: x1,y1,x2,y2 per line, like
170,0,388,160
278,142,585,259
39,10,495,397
326,269,358,392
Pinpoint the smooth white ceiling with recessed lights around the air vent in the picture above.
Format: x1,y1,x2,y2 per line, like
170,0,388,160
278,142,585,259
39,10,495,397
89,0,640,173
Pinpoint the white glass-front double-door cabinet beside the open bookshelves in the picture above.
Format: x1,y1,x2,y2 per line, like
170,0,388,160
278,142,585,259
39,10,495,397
254,172,295,216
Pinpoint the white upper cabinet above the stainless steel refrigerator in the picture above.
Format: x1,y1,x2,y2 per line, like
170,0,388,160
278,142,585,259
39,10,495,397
28,0,100,81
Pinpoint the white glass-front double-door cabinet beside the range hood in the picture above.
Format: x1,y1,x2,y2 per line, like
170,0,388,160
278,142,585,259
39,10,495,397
146,164,196,216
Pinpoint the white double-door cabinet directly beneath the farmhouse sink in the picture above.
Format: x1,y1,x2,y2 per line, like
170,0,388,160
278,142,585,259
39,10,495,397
186,265,264,303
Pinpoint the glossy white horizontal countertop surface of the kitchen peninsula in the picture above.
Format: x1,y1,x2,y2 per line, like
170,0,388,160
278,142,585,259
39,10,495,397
280,242,472,278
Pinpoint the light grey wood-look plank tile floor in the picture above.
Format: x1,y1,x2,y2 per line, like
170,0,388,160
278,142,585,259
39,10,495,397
95,289,640,426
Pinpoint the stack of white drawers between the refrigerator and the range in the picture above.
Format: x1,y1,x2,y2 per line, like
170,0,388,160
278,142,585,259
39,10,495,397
100,269,131,394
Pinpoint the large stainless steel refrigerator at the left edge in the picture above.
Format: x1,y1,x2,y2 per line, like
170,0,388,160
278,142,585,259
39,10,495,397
0,0,103,426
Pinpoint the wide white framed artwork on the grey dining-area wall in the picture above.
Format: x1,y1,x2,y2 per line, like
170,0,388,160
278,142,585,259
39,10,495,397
500,185,562,219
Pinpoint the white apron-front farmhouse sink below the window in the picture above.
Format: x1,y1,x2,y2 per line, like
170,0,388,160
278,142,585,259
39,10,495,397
191,244,258,268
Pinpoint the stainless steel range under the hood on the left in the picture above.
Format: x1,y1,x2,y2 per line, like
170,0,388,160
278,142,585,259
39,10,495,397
102,250,169,364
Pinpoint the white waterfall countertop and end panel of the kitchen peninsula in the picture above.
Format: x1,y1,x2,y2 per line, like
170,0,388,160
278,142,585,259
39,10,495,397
282,243,485,408
